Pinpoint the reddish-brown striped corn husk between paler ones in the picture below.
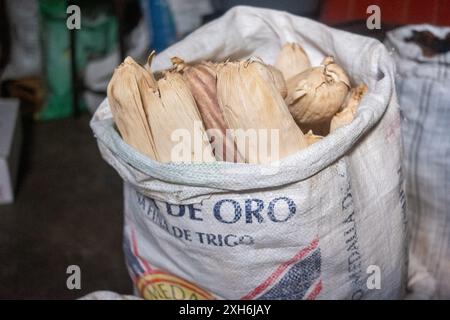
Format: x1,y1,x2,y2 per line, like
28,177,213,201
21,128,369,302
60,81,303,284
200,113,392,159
171,57,244,162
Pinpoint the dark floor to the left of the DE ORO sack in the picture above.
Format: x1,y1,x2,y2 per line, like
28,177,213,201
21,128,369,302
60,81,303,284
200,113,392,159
0,115,132,299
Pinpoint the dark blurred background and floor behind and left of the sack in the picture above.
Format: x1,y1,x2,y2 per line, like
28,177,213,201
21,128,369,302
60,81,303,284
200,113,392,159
0,0,450,299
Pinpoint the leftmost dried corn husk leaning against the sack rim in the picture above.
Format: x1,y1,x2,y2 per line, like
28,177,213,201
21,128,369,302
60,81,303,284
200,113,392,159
108,57,157,160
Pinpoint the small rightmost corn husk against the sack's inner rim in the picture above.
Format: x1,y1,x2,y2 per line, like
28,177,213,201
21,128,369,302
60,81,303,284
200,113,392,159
330,84,368,132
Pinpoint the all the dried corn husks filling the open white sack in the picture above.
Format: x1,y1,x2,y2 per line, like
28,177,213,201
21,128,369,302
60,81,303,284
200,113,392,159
108,43,367,164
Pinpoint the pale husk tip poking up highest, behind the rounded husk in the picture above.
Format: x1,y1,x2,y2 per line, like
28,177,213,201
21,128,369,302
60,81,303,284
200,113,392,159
275,42,311,81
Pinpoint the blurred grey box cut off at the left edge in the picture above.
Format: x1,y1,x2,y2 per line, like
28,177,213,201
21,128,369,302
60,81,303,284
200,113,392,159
0,98,22,204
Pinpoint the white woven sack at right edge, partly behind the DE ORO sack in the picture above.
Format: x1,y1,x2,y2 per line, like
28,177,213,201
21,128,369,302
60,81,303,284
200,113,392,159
386,25,450,299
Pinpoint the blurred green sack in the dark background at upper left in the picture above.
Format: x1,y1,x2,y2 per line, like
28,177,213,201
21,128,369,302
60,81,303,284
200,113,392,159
35,0,118,120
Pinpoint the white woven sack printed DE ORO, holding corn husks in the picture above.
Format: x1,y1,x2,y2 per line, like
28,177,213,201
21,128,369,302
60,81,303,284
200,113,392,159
91,7,407,299
